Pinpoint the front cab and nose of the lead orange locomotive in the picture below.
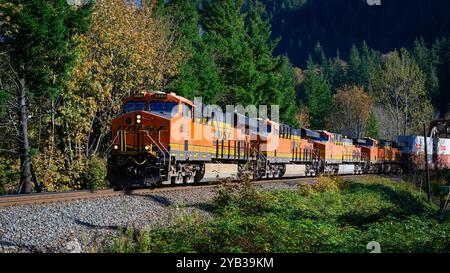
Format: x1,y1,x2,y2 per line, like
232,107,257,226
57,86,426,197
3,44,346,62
108,92,194,187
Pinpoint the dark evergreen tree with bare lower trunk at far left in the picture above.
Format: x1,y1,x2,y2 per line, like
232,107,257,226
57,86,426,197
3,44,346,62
0,0,91,193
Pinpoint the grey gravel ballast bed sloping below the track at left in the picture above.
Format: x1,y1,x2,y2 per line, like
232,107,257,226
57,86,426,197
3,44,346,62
0,182,298,253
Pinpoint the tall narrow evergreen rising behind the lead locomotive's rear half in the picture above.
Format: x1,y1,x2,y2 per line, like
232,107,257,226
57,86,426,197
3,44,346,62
202,0,259,107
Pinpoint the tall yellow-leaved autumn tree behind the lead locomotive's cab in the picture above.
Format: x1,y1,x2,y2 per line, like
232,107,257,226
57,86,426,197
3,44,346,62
61,0,183,157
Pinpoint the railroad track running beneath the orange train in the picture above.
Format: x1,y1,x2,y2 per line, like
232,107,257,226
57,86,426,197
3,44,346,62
0,175,380,208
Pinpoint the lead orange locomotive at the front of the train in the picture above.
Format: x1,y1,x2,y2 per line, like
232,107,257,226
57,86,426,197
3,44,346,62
108,93,252,186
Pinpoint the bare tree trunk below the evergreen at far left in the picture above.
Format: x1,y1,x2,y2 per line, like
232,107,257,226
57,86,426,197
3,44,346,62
18,77,32,194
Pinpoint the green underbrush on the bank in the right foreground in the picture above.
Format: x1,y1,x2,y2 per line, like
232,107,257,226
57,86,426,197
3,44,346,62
103,177,450,253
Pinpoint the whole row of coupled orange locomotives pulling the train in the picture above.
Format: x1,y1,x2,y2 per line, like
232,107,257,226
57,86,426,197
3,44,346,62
108,92,400,187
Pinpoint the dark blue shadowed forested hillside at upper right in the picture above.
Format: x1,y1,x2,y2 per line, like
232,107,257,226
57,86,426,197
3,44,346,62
263,0,450,66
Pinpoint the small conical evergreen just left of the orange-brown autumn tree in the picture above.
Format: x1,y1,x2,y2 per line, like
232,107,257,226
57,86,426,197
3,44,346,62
301,59,333,130
